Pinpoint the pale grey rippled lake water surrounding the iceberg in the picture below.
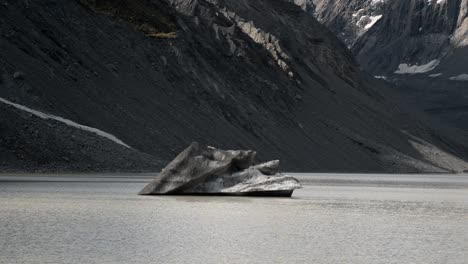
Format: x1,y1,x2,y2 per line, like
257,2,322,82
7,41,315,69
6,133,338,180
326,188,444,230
0,174,468,264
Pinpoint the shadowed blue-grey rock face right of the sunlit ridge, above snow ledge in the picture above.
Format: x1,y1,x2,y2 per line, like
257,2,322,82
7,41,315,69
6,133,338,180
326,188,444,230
353,0,468,75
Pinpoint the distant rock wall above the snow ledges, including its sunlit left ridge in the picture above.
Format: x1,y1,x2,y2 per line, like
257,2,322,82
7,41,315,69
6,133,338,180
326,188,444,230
308,0,468,76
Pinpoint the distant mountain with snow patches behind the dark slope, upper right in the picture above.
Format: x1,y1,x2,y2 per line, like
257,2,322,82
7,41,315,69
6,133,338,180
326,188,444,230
315,0,468,133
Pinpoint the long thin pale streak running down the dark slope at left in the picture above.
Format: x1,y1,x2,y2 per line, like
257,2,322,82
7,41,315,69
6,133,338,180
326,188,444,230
0,97,130,148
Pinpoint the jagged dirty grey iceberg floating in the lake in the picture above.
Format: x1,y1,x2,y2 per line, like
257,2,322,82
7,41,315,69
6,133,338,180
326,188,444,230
139,142,301,197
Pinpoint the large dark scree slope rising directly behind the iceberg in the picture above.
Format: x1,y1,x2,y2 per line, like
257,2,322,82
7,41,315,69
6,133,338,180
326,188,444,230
0,0,468,172
